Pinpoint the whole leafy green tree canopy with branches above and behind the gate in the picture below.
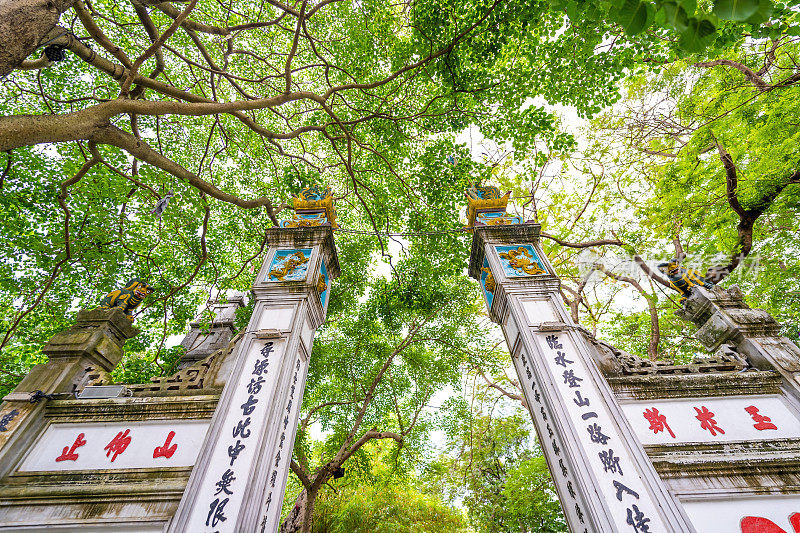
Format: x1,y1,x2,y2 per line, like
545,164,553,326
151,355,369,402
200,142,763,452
0,0,800,532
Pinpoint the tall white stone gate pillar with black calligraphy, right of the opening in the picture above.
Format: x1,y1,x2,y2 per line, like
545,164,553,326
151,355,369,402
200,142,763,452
468,187,695,533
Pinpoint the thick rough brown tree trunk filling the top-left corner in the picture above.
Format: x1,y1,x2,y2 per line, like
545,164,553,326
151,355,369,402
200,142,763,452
0,0,74,77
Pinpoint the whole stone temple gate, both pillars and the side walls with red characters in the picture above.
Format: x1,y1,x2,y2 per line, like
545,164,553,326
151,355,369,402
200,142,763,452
0,187,800,533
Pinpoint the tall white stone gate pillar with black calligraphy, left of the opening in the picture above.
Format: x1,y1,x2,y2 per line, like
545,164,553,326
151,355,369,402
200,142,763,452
166,190,339,533
